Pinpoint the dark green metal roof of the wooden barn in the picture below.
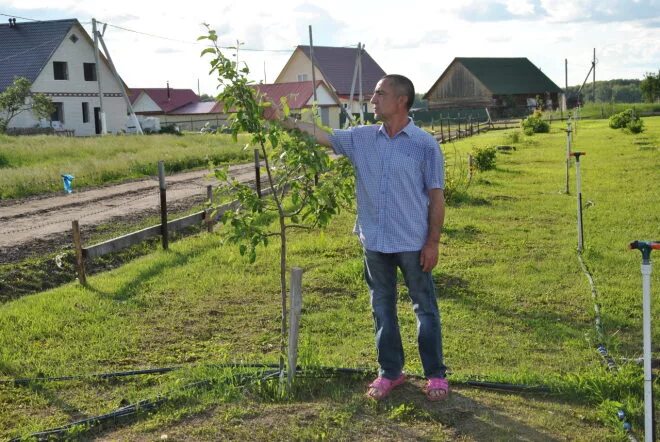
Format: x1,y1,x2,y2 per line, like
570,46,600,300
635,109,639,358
454,57,562,95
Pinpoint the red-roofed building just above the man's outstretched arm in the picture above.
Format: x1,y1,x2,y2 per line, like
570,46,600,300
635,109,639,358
254,80,341,129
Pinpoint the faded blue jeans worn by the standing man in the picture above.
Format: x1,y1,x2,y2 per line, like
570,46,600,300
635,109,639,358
364,249,447,379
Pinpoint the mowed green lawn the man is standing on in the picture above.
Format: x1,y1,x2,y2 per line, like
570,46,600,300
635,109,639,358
0,118,660,441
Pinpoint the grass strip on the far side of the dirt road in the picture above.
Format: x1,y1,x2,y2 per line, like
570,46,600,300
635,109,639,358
0,133,252,200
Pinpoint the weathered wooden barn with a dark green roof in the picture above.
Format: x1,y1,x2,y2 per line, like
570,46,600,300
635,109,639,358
424,57,563,116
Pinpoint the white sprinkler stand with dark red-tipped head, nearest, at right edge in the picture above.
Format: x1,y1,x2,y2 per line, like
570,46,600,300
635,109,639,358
628,241,660,442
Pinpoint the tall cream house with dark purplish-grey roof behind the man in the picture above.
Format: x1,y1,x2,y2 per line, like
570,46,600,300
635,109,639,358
275,46,385,114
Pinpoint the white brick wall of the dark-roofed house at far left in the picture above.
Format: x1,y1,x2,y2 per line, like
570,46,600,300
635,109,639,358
10,25,127,136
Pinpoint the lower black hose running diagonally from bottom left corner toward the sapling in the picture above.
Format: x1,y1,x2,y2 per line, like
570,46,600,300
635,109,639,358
11,370,279,442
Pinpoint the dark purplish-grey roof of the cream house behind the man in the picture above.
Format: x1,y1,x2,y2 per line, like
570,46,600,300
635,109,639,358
296,45,385,95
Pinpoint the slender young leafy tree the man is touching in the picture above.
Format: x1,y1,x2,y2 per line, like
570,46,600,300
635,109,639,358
199,25,354,373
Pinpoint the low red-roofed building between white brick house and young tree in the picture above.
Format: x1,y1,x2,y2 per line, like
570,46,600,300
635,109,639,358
128,86,227,131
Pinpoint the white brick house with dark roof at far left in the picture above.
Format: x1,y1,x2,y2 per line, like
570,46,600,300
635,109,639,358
0,19,127,136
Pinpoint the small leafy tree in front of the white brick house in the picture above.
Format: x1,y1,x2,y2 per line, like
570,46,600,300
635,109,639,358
0,77,55,133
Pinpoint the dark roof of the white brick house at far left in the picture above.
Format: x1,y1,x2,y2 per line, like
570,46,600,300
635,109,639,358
0,18,80,91
